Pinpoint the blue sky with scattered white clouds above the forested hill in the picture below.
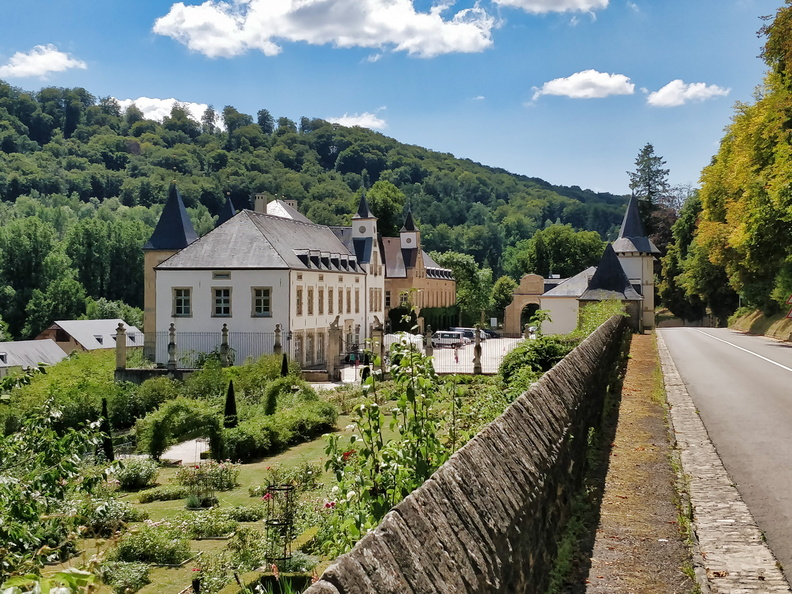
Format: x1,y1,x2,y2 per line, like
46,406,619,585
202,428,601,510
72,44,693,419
0,0,783,194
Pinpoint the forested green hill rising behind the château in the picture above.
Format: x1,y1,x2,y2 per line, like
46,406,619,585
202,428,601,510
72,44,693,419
0,81,626,334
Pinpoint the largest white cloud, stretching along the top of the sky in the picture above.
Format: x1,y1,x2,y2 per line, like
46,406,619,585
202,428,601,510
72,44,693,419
153,0,496,58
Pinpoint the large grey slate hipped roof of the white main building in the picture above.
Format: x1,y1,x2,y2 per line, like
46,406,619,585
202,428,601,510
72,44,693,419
157,208,360,272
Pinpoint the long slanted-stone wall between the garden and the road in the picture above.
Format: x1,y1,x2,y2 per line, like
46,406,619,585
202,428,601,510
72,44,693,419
306,317,628,594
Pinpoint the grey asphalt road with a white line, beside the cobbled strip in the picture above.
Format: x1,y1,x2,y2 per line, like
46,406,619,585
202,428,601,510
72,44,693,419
660,328,792,579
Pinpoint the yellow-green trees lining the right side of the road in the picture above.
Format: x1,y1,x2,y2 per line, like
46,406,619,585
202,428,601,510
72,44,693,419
661,0,792,319
